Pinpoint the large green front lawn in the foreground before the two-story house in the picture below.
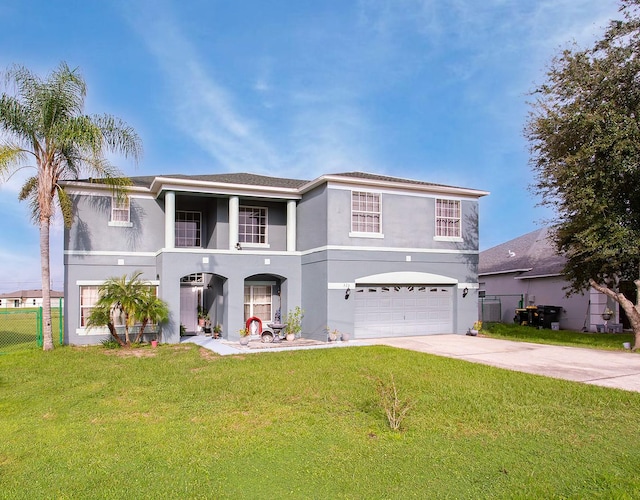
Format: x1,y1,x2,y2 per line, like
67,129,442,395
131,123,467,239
0,345,640,499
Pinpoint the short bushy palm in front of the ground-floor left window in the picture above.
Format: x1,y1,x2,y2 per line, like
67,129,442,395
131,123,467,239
87,271,169,346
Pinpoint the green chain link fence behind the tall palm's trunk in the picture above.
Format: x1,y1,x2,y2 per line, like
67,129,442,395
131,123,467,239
0,305,63,354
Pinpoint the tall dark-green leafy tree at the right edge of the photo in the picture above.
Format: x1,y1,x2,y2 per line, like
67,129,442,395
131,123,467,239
525,0,640,349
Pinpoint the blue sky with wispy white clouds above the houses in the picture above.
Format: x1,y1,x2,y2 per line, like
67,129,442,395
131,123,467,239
0,0,618,292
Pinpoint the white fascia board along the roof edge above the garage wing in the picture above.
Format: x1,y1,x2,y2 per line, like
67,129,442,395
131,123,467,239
300,175,489,199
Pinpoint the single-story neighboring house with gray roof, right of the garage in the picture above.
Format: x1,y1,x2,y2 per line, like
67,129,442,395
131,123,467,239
478,228,626,331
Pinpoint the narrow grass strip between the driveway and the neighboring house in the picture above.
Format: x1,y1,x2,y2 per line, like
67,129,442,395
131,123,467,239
482,323,634,351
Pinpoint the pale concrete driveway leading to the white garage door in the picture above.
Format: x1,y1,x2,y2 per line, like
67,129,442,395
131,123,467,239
367,335,640,392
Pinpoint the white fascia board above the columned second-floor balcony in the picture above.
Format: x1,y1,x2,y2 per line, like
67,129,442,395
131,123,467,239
150,177,302,200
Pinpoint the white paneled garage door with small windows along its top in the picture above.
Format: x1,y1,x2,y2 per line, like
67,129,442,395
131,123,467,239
354,285,453,338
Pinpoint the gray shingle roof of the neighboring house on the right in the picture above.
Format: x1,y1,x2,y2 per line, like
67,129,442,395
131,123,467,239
478,228,565,278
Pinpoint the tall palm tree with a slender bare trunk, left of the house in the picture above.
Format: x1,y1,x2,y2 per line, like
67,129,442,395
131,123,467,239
0,63,142,351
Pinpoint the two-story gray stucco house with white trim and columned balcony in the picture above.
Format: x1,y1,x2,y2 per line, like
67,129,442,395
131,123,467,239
64,172,488,344
